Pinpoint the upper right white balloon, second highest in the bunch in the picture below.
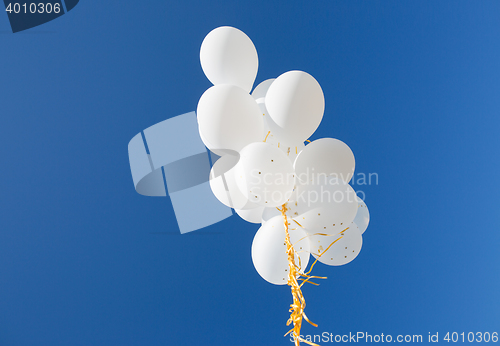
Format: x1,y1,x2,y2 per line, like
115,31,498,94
265,71,325,143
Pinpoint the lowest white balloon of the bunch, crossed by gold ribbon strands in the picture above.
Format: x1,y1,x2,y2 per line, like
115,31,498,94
252,216,310,285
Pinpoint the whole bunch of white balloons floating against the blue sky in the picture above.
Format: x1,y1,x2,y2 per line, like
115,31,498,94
197,27,369,344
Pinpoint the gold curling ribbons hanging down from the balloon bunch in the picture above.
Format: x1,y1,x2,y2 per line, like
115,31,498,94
277,203,349,346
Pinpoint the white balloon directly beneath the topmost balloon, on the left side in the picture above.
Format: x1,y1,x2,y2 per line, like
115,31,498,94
197,85,264,151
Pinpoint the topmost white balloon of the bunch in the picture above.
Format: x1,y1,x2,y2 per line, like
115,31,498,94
200,26,259,93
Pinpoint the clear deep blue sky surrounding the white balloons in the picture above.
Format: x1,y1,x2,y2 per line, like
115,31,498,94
0,0,500,346
